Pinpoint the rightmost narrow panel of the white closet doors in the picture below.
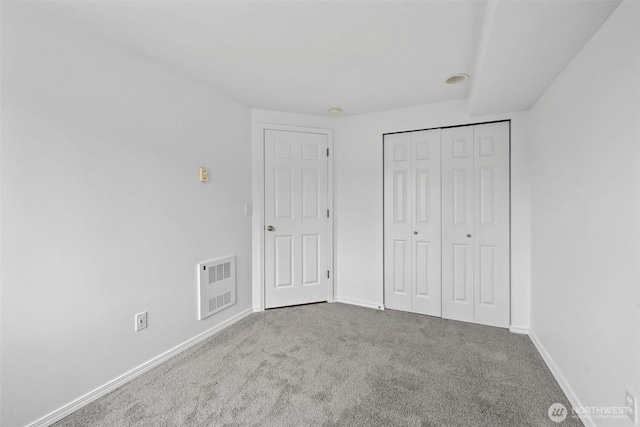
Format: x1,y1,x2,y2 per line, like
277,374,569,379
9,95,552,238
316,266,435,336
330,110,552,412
473,122,510,327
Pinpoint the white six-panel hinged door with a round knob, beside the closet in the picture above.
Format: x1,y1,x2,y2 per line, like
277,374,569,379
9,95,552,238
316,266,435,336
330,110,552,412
264,130,329,308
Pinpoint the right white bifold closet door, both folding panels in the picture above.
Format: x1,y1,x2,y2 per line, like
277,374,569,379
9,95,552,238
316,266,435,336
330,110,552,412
442,122,510,327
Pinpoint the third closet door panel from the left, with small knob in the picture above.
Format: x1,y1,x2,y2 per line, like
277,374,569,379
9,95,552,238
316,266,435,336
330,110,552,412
441,126,474,322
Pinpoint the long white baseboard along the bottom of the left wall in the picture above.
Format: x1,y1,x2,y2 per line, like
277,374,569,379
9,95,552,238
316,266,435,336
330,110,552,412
28,308,253,427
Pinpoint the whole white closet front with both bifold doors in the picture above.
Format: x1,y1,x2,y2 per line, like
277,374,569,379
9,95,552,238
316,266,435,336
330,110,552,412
384,121,510,327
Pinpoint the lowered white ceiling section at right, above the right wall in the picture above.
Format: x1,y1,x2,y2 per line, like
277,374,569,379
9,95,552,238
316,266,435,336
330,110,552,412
471,1,620,114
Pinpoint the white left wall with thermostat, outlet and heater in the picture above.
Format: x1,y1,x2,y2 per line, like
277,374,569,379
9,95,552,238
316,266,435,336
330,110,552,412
0,2,251,427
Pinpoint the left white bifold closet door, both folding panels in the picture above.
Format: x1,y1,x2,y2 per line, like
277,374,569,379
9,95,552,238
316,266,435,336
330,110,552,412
384,129,441,316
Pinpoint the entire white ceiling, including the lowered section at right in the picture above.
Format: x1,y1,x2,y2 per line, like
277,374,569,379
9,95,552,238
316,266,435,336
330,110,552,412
38,1,619,115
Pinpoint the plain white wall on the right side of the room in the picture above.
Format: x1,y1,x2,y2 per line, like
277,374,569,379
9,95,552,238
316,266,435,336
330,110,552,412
530,1,640,426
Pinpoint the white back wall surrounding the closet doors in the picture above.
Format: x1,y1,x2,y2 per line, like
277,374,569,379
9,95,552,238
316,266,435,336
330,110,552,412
335,101,529,330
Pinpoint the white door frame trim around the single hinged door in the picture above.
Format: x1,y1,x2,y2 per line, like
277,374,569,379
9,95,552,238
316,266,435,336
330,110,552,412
251,123,336,312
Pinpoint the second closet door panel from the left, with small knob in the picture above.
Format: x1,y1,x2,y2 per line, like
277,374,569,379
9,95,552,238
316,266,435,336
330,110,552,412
411,129,441,316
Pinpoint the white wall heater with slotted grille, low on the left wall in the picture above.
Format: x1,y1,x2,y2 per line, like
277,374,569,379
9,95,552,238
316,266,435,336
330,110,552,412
198,256,236,320
